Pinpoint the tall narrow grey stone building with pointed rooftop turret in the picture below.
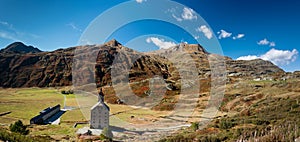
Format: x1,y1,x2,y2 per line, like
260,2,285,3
90,88,110,129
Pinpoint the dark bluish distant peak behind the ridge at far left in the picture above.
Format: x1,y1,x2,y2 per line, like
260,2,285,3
0,42,42,54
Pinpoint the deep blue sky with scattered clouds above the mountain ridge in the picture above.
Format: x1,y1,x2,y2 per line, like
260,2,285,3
0,0,300,71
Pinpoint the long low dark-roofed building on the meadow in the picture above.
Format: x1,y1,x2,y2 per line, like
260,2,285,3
30,104,60,124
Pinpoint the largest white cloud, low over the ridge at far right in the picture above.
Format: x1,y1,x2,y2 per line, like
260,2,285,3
237,48,298,65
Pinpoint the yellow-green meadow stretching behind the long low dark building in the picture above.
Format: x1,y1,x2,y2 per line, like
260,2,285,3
0,88,63,124
